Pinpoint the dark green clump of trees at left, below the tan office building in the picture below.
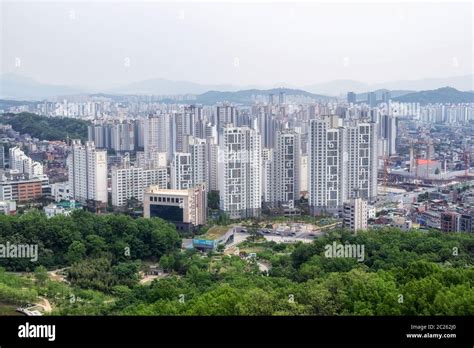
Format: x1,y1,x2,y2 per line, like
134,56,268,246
0,210,181,274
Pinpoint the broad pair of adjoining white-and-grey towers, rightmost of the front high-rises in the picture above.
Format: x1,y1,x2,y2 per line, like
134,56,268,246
308,116,377,214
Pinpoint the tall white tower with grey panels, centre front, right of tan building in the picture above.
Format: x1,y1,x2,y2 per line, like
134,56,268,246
219,126,262,219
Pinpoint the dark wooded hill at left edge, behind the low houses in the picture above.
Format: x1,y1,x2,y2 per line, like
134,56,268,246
0,112,89,141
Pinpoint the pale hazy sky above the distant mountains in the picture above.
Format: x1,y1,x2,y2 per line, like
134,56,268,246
0,0,473,88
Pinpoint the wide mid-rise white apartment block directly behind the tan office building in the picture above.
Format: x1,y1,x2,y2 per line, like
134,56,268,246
112,167,168,207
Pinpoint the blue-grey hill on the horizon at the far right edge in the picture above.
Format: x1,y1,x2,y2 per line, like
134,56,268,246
393,87,474,104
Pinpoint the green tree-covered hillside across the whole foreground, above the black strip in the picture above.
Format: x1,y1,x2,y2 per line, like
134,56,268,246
0,211,474,315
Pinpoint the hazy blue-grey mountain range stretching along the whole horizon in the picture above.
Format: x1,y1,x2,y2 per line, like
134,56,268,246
0,74,474,104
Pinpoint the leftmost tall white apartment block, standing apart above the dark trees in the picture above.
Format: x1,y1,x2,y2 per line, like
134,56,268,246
67,140,107,203
